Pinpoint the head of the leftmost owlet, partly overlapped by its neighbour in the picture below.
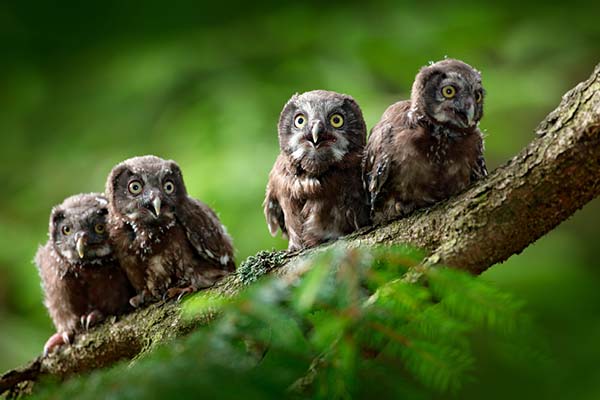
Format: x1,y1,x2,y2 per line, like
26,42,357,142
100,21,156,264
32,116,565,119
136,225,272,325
49,193,112,264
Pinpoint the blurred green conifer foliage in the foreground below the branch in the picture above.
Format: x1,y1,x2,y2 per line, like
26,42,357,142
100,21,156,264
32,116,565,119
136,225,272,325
31,246,545,399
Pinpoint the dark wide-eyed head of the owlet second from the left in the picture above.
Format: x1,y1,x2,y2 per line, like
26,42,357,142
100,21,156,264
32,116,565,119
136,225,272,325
106,156,187,226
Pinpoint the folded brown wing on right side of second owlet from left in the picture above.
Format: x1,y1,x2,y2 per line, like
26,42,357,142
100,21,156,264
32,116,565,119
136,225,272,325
177,197,235,271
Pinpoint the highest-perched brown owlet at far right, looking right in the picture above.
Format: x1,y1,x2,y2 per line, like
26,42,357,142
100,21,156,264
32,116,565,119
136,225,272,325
364,59,487,224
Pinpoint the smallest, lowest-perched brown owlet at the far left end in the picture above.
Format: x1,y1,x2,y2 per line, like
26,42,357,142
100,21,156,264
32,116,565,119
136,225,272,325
35,193,134,354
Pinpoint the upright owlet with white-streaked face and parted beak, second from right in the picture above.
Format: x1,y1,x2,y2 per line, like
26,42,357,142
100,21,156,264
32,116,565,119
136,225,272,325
263,90,369,250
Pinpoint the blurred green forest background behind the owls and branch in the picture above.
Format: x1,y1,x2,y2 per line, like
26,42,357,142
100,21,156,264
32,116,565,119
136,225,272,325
0,0,600,398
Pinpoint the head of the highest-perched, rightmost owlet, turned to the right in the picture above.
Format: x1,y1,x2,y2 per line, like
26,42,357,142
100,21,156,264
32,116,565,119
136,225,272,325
411,59,485,129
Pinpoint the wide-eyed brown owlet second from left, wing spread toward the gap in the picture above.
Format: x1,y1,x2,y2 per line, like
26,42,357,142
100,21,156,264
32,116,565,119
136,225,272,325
106,156,235,307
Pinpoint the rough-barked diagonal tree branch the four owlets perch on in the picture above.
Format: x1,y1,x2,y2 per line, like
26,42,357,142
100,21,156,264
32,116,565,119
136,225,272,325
0,64,600,394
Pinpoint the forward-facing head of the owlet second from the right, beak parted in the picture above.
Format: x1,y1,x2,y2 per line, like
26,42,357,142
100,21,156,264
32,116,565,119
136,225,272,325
278,90,367,173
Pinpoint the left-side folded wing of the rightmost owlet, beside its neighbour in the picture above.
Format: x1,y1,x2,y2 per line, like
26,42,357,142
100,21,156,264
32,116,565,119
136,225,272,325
363,124,393,210
